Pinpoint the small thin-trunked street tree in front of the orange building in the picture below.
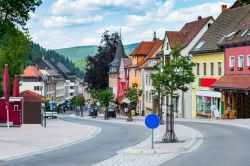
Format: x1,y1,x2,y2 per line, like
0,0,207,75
125,85,142,121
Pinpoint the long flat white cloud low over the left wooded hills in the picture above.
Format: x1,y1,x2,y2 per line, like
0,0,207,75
43,15,103,27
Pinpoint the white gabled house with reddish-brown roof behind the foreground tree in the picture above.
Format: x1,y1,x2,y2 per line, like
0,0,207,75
161,16,214,118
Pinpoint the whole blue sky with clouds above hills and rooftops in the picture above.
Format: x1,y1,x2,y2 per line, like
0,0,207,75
27,0,235,49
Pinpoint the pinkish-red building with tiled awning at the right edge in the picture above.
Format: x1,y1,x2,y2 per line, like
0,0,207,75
212,5,250,118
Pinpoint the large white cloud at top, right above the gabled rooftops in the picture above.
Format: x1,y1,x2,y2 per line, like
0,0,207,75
125,0,230,26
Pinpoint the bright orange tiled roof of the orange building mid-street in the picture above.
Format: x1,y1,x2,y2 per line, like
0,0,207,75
130,40,163,68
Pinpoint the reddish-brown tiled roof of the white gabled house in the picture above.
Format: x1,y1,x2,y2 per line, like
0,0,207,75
165,16,213,48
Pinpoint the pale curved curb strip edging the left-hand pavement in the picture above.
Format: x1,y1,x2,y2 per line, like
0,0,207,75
0,127,102,161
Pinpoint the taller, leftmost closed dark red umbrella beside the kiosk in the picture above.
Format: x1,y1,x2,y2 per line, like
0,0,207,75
3,64,10,127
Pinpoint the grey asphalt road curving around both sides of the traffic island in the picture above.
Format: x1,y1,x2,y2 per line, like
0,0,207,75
0,117,250,166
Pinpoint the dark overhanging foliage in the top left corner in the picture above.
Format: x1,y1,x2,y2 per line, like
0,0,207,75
0,0,42,27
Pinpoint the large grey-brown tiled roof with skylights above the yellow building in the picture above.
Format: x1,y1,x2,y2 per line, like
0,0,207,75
191,5,250,54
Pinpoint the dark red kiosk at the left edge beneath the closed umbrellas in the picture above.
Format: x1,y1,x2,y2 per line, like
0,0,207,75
0,97,23,126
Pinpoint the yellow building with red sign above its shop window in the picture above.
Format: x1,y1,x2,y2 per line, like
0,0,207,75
192,52,224,118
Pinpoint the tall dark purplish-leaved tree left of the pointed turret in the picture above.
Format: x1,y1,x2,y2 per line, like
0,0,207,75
85,31,120,89
